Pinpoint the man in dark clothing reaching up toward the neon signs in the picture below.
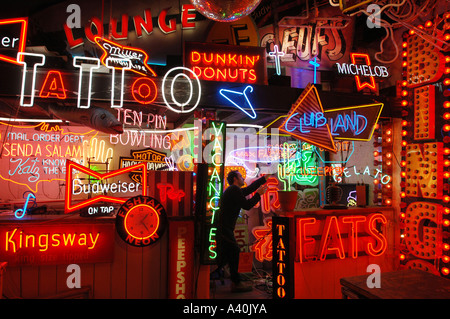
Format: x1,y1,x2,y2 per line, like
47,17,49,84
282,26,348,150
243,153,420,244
216,171,267,291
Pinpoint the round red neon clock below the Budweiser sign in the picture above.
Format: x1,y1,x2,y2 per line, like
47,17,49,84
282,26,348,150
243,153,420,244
116,195,167,247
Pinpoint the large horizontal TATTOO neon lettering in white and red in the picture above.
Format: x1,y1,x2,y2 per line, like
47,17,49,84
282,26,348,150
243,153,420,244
17,52,201,113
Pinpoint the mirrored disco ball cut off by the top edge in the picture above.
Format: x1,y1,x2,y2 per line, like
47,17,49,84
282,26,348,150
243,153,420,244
191,0,261,22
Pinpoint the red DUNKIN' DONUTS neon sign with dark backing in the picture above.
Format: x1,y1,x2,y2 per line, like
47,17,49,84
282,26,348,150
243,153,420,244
184,42,267,84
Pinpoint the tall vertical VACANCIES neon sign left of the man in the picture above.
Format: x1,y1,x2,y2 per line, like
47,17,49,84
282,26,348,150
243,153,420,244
206,122,225,260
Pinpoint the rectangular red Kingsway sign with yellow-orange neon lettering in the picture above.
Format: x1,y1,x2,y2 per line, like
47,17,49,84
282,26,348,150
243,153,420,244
0,223,114,266
